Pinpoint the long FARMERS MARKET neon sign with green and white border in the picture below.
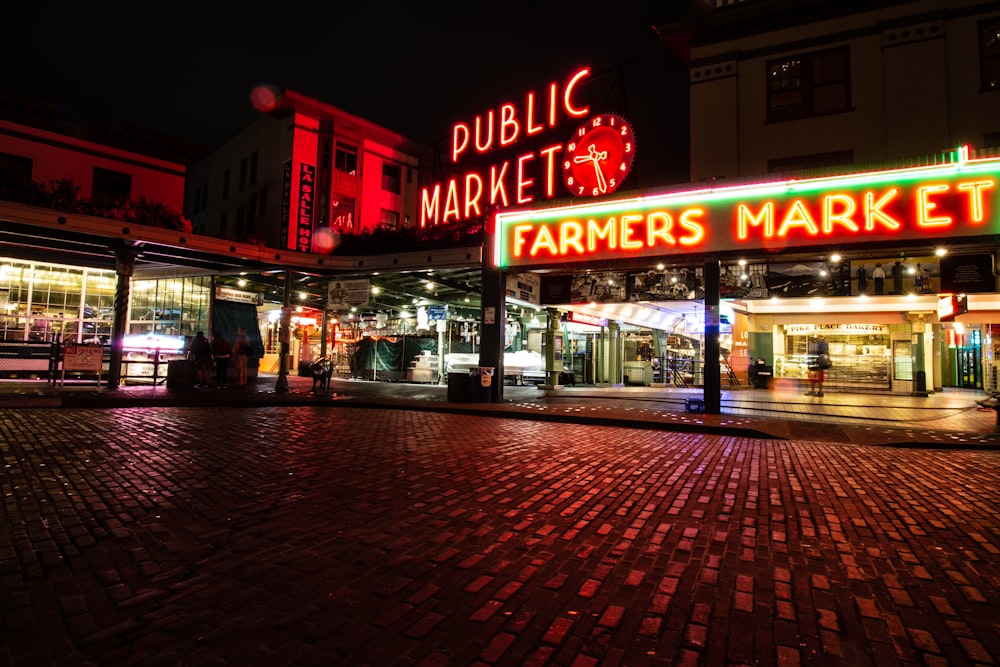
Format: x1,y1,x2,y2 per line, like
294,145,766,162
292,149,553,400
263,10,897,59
494,148,1000,267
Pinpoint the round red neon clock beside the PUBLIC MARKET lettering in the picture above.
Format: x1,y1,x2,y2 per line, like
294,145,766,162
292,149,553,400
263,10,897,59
562,114,635,197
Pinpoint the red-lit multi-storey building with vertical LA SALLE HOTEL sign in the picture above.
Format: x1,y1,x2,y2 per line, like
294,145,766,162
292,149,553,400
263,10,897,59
185,90,428,254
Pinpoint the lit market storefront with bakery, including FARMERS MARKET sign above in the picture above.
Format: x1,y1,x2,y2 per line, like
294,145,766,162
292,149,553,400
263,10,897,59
493,149,1000,402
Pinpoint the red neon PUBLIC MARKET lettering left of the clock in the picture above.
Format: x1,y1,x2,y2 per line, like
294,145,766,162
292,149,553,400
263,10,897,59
420,67,590,227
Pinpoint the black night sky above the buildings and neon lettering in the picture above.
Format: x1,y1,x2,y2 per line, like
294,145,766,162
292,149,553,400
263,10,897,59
0,0,688,187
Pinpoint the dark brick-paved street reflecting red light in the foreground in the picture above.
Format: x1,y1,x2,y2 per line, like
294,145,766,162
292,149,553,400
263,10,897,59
0,407,1000,667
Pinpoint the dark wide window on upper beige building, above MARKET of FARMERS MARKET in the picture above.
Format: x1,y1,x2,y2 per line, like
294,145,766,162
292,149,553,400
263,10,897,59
767,47,851,123
